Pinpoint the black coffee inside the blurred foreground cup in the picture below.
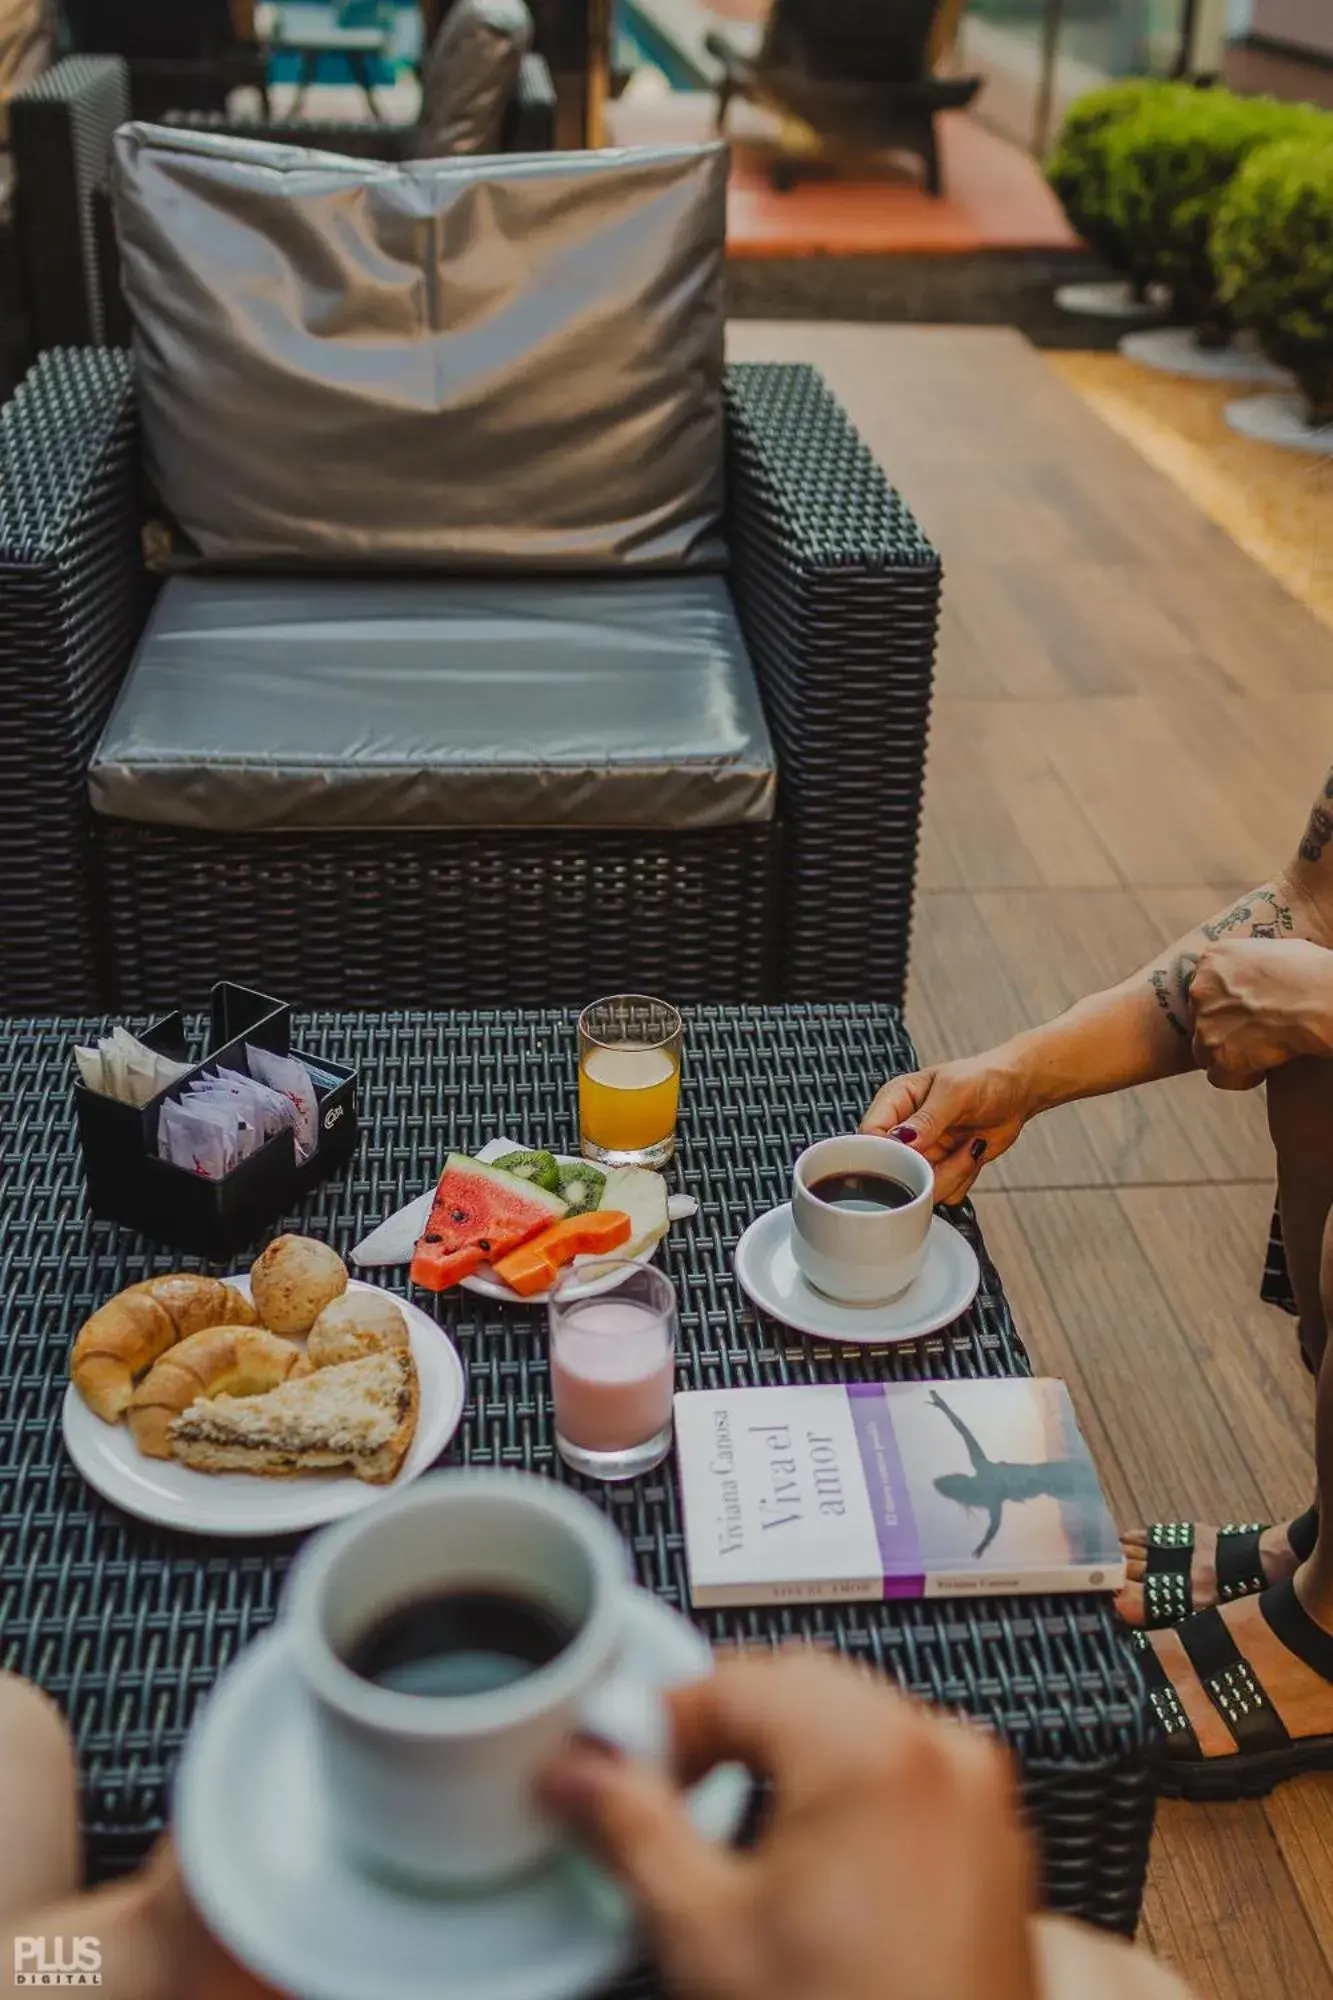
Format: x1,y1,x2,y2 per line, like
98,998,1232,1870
344,1590,574,1696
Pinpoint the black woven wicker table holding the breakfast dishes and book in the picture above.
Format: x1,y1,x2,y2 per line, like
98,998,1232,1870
0,1006,1155,1952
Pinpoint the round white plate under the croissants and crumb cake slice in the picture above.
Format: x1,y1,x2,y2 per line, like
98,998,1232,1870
60,1278,466,1536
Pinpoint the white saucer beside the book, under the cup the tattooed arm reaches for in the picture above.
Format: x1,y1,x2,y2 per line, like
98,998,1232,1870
735,1202,981,1348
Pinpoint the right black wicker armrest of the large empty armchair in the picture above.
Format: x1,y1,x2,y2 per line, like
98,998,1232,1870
727,364,941,1004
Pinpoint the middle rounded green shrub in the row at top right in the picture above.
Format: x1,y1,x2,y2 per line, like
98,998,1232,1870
1103,90,1327,348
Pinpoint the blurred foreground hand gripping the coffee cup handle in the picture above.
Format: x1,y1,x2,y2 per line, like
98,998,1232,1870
544,1654,1037,2000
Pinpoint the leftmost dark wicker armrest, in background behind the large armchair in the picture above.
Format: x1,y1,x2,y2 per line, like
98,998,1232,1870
10,56,130,352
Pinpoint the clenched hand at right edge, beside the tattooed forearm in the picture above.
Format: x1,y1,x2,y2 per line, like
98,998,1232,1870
1189,938,1333,1090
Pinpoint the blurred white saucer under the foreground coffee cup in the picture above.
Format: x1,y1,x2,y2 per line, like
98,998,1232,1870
172,1590,749,2000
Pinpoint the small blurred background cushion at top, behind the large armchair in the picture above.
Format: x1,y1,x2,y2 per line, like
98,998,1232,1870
416,0,532,158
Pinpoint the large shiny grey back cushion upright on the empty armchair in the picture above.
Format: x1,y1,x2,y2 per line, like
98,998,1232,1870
116,124,727,570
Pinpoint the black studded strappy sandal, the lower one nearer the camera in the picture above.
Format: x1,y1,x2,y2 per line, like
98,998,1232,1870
1133,1580,1333,1800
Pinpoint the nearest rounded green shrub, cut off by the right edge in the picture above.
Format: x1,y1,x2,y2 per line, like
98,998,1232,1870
1211,140,1333,442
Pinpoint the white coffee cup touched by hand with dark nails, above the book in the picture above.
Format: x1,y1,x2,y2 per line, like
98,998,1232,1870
791,1132,935,1306
